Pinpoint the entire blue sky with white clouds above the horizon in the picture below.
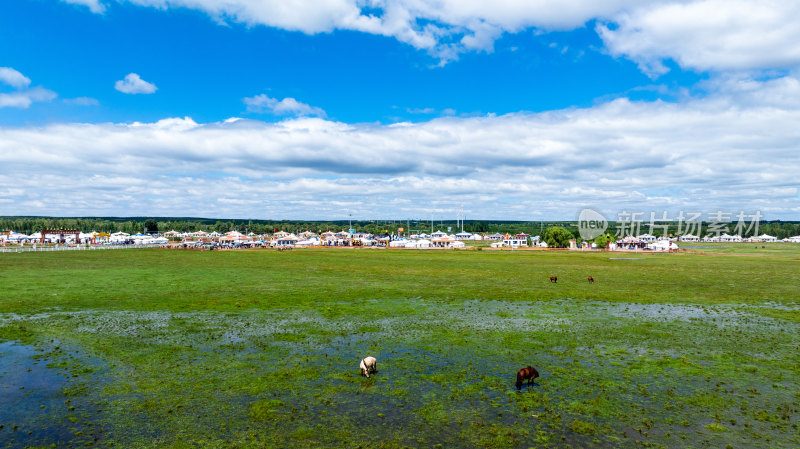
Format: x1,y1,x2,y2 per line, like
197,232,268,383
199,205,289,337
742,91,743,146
0,0,800,221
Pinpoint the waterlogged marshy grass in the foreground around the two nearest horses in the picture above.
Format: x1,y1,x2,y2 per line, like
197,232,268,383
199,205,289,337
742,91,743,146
0,298,800,448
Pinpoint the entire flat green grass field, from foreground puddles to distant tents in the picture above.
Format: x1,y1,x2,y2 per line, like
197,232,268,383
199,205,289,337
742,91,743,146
0,244,800,448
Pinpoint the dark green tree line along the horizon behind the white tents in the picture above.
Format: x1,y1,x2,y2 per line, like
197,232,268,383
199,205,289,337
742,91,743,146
0,217,800,240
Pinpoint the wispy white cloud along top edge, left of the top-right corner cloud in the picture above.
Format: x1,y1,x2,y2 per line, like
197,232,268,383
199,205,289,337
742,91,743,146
76,0,653,63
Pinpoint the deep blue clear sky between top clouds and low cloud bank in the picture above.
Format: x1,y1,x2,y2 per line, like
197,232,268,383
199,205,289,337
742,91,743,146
0,0,699,124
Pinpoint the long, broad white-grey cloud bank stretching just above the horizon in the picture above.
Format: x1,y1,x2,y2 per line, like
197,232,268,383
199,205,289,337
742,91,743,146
0,76,800,220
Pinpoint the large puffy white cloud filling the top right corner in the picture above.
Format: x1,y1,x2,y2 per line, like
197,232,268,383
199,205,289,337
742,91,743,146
597,0,800,75
